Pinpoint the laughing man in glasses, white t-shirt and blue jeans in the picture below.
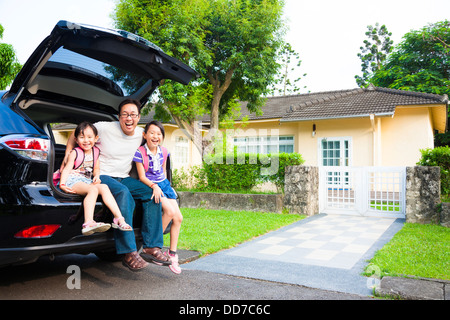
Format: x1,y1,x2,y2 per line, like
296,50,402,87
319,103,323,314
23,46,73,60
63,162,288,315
61,99,171,271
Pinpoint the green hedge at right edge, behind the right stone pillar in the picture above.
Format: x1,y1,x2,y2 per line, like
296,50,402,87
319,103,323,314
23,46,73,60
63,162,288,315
417,146,450,194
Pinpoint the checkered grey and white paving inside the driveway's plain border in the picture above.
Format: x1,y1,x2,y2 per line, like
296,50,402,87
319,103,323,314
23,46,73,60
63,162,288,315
227,215,395,269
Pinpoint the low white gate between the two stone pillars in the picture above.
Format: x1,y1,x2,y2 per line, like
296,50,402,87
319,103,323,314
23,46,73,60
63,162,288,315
319,166,406,218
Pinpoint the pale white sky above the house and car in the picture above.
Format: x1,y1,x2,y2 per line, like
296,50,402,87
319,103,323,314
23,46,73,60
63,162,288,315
0,0,450,93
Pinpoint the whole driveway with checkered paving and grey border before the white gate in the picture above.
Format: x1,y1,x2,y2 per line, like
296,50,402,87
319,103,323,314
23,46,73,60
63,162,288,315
183,214,404,296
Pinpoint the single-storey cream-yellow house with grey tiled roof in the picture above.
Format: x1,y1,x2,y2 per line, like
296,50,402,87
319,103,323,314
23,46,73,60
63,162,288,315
54,86,448,168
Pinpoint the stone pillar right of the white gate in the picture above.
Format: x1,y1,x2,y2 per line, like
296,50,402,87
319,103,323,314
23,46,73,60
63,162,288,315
406,166,441,223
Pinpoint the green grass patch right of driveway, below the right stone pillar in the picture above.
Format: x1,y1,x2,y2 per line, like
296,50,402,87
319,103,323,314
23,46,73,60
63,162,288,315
370,223,450,280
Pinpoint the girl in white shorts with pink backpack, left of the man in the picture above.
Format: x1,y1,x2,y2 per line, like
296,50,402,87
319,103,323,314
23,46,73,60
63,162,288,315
59,122,133,235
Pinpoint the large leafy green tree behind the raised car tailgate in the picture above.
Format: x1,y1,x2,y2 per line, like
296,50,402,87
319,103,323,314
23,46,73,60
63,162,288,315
114,0,284,154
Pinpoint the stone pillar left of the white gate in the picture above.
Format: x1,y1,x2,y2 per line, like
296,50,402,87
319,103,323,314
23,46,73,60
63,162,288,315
283,166,319,216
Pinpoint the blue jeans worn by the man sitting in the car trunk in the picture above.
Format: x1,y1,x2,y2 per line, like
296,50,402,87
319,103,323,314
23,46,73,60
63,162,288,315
100,175,164,254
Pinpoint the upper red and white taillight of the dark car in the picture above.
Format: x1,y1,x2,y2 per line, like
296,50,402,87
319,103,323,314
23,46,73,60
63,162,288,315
0,135,50,161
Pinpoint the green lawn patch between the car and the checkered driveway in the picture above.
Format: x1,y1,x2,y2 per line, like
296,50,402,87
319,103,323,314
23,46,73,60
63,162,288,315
164,208,305,255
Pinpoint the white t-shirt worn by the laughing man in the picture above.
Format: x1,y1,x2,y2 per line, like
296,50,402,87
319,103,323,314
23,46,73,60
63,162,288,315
95,121,144,178
